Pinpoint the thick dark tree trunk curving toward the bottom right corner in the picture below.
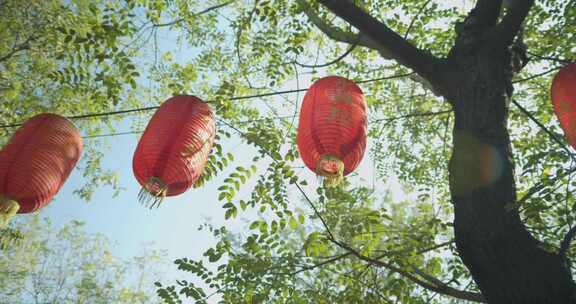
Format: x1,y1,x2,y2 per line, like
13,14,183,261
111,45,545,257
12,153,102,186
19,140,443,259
447,47,576,304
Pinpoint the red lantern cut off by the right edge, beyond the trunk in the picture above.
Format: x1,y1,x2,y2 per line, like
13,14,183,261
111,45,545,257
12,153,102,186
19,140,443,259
552,63,576,148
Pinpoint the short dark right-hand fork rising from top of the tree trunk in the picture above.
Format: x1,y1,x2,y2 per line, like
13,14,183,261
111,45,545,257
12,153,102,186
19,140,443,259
487,0,534,47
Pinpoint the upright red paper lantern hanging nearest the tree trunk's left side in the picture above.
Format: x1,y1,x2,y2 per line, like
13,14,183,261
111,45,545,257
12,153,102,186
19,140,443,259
296,76,367,185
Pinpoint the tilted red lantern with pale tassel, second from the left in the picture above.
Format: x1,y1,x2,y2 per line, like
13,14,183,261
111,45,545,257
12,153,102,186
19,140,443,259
132,96,216,207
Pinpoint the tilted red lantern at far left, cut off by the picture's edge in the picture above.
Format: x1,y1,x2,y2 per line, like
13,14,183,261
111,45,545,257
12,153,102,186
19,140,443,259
0,114,82,225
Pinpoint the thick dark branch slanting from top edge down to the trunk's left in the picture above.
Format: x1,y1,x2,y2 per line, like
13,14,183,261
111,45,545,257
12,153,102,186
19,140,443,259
319,0,438,83
